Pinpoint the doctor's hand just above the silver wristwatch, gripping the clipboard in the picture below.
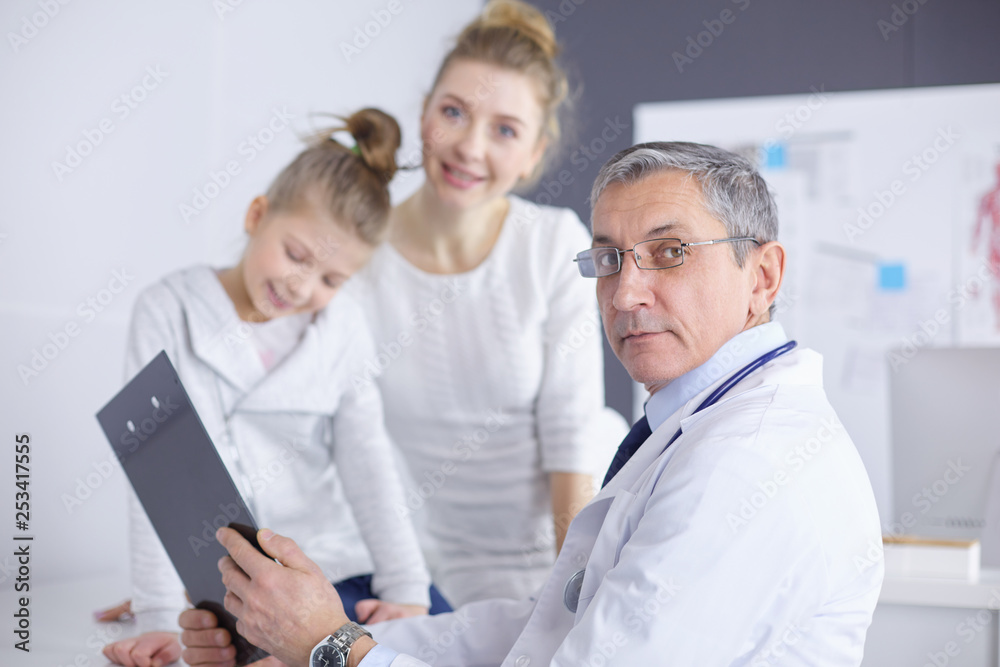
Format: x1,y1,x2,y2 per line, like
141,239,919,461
216,528,370,667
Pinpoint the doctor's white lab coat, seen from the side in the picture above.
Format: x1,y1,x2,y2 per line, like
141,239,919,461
373,349,883,667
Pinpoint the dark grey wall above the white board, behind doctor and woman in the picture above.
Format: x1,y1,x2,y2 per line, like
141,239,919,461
528,0,1000,416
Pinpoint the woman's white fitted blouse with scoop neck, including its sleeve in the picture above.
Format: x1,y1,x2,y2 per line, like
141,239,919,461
348,197,628,605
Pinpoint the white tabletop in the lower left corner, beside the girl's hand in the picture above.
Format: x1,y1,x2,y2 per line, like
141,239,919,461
0,574,184,667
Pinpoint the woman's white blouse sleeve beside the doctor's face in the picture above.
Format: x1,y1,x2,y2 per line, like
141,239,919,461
535,209,628,476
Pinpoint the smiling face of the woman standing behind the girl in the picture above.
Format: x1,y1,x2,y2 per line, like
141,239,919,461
420,60,545,208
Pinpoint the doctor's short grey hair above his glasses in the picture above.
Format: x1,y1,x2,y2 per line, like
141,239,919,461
590,141,778,268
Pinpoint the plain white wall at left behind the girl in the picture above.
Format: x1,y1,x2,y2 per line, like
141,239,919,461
0,0,480,584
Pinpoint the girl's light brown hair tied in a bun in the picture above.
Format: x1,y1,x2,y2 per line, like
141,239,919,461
266,108,400,245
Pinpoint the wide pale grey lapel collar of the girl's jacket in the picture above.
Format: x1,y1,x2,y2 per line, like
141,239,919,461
161,266,333,412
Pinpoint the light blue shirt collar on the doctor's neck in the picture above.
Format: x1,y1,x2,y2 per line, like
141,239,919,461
646,322,788,431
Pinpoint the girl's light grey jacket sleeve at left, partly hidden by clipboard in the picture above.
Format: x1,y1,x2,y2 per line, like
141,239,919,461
125,285,188,632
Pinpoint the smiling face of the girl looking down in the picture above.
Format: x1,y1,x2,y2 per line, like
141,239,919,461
241,196,374,321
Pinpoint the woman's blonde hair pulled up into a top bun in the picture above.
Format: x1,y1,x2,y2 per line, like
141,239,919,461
431,0,569,176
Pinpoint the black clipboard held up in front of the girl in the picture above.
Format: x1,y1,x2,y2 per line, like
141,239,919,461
97,352,270,665
